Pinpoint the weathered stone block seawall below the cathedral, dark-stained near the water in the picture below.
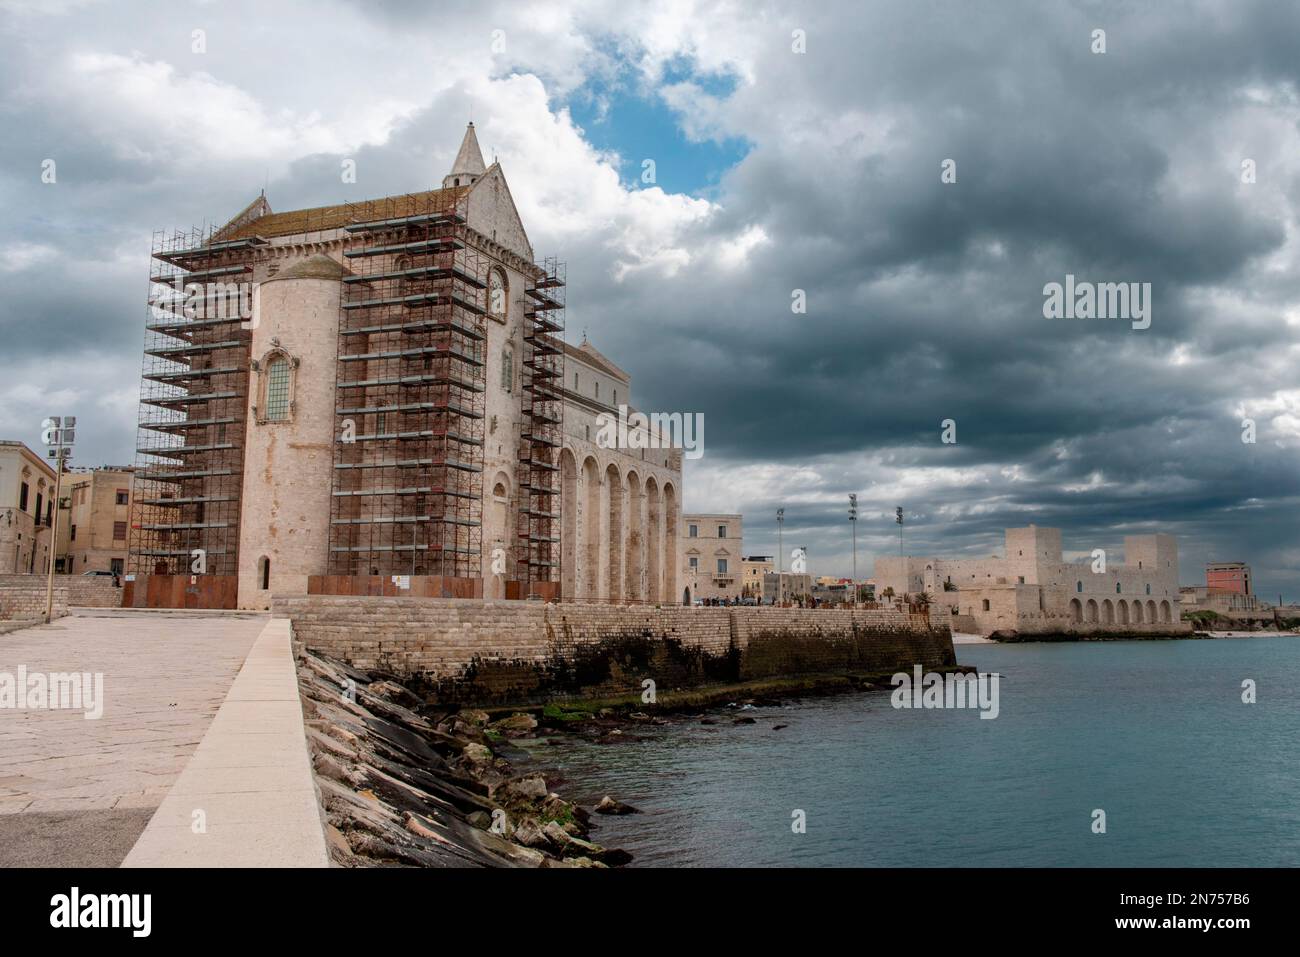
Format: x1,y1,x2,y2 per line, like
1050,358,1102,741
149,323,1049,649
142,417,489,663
274,596,956,703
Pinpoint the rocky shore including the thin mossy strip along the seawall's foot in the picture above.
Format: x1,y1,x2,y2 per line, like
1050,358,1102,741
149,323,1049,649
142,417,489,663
296,648,970,867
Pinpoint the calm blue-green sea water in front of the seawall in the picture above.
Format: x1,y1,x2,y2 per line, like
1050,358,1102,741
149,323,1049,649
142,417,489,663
538,637,1300,867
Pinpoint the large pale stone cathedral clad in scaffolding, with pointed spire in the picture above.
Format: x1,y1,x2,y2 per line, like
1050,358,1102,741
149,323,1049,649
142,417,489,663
124,124,683,609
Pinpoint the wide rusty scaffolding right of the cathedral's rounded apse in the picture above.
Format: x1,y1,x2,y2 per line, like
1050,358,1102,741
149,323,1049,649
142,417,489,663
329,191,489,582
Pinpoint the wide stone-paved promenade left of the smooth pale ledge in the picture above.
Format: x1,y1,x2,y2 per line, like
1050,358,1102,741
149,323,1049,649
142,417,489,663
0,610,269,867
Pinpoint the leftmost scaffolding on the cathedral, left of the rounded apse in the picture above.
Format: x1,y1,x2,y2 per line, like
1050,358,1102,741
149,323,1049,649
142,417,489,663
127,229,265,577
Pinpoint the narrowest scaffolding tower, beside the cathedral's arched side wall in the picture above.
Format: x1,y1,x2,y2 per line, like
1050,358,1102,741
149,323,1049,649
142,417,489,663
516,259,566,598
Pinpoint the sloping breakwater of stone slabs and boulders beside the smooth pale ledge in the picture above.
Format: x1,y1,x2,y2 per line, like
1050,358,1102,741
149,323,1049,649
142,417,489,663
298,651,632,867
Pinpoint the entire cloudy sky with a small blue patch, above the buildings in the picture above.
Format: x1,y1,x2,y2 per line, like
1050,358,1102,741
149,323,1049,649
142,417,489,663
0,0,1300,601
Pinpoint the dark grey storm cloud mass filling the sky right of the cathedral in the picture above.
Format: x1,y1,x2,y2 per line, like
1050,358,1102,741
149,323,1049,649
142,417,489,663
579,5,1300,588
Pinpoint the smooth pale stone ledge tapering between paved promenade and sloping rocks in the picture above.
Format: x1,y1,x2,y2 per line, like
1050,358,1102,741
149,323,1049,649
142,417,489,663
122,618,329,867
